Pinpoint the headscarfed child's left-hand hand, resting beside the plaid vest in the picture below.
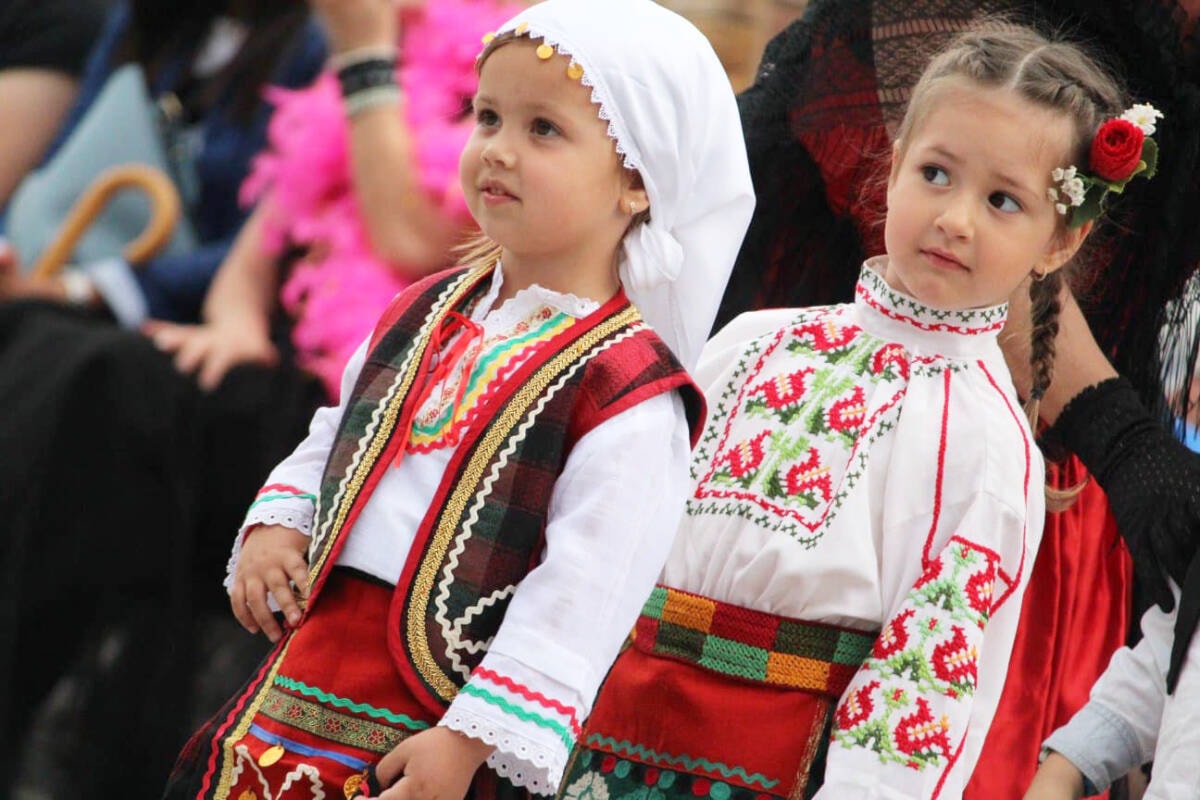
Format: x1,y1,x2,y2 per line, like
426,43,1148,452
229,525,308,642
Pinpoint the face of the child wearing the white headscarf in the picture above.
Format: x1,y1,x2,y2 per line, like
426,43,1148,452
458,40,646,278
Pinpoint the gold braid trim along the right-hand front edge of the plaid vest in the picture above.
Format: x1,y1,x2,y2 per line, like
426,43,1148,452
404,306,641,702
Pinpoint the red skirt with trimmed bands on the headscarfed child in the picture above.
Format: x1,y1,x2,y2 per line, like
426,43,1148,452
166,570,437,800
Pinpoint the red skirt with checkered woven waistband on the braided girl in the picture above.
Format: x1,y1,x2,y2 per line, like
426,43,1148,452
560,587,875,800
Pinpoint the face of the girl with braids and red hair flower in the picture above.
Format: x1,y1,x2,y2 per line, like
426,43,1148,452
884,83,1082,308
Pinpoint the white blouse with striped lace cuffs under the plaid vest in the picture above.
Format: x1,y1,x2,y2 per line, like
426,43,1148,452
226,267,691,794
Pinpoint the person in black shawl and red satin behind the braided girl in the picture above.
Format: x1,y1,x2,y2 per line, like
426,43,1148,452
718,0,1200,800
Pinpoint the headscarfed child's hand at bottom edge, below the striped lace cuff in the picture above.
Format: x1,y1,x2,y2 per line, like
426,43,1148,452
376,726,494,800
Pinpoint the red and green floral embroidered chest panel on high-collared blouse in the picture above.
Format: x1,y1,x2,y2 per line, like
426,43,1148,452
688,307,908,547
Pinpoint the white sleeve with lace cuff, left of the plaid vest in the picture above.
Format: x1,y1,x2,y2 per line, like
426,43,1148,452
224,341,368,591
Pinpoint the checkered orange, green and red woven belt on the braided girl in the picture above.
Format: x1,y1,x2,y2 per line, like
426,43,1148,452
634,585,877,697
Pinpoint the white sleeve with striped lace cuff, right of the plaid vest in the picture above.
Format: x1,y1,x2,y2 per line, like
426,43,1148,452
440,392,690,794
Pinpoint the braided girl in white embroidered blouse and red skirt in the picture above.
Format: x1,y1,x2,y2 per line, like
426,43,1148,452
563,26,1144,800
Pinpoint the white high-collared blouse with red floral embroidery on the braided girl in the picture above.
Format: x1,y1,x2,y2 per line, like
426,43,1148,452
664,259,1044,800
